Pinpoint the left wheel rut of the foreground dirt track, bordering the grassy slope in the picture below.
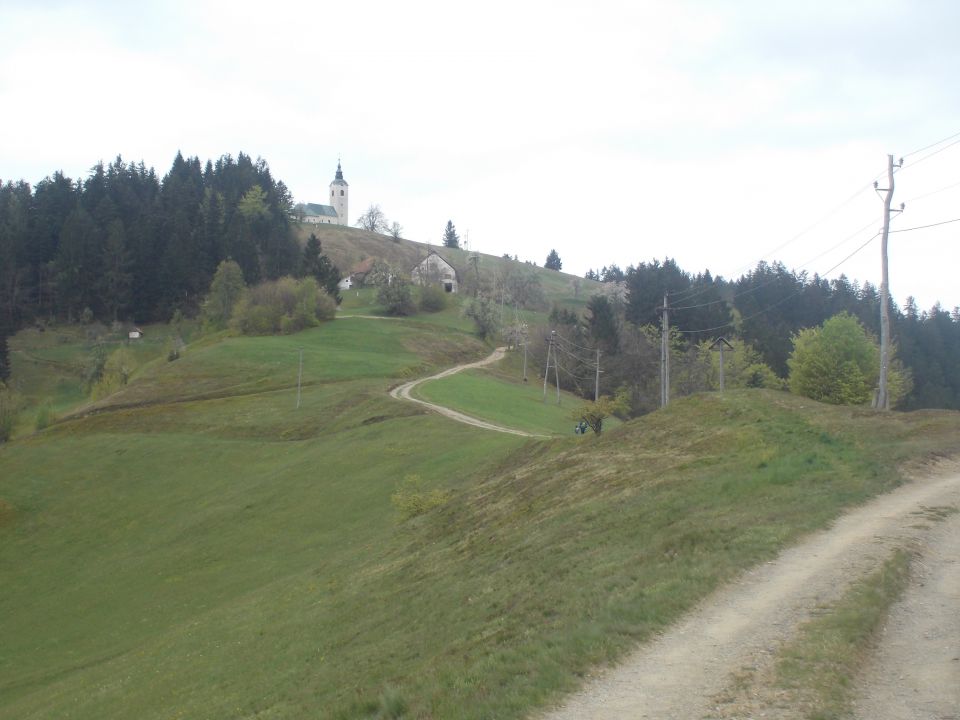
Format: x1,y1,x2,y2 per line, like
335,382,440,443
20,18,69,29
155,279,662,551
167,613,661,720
537,464,960,720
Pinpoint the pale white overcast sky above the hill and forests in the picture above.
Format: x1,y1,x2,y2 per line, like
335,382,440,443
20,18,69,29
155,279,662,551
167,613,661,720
0,0,960,308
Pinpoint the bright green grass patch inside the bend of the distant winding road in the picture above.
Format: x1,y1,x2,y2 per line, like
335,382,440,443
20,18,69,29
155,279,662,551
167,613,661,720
413,370,592,436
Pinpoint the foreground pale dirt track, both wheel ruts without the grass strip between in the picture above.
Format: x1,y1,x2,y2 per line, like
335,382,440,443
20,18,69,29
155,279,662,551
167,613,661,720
538,464,960,720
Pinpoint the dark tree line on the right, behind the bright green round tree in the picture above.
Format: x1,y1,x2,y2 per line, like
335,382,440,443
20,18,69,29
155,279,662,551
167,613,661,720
551,259,960,412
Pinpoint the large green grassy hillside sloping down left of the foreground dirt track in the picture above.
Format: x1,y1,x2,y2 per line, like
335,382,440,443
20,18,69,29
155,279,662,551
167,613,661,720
0,311,960,720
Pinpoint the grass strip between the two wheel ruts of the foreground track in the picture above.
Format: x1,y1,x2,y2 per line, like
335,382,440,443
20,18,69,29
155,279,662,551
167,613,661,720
776,550,910,720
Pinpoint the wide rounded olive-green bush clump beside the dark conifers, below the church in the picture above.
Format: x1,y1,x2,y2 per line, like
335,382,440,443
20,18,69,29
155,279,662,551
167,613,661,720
231,277,337,335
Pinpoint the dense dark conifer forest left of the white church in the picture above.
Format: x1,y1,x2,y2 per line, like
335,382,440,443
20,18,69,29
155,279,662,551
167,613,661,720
0,153,312,379
